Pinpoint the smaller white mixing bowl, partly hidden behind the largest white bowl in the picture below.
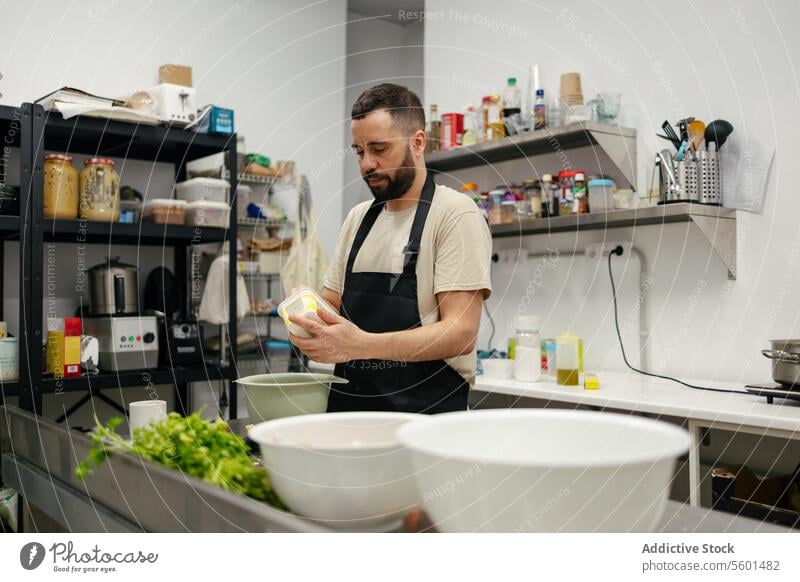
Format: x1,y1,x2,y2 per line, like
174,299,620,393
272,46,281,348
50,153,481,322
249,412,419,529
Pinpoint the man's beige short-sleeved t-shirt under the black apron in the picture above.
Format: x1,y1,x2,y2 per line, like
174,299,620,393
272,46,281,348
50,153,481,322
323,185,492,385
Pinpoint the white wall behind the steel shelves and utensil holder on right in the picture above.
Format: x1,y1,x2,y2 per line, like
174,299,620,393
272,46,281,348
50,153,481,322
425,0,800,381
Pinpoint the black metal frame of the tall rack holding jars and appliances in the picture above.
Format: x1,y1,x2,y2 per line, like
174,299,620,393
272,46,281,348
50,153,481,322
10,103,238,419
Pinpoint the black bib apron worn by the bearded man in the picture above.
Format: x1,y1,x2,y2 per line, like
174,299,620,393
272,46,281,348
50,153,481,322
328,174,469,414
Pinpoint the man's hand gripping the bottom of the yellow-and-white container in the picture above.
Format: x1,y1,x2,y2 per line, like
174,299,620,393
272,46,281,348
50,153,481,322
289,309,371,364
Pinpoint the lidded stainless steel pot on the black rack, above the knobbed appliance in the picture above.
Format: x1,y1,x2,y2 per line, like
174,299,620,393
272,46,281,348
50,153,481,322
89,257,139,315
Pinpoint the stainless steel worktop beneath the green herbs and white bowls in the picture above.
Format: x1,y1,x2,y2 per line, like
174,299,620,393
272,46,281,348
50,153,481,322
0,406,794,533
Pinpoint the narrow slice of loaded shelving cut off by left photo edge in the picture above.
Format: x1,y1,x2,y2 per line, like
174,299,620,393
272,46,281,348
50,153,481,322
0,105,33,397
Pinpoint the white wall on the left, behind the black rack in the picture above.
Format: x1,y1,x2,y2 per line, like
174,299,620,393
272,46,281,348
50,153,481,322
0,0,346,420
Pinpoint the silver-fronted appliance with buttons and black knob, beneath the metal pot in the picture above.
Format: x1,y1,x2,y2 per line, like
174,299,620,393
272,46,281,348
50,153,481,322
83,316,158,372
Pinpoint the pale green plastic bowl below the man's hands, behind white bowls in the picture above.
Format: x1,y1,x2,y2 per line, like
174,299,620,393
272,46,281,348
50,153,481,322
231,373,347,423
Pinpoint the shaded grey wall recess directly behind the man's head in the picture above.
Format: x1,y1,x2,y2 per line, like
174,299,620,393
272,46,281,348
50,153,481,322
342,12,425,216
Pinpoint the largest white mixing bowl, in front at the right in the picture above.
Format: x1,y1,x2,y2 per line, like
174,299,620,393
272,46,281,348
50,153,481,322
397,409,689,532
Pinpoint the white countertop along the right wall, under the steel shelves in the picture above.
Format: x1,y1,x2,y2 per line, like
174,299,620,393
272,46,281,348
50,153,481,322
473,372,800,438
